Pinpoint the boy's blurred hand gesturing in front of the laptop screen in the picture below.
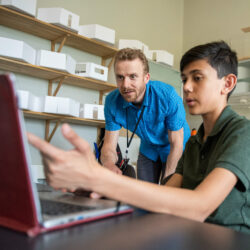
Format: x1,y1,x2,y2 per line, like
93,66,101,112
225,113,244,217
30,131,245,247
27,124,102,193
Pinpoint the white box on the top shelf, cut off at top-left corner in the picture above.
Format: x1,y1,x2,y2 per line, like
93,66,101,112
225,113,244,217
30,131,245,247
0,0,36,16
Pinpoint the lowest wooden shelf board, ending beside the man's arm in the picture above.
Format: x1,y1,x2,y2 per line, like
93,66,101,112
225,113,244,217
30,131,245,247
23,110,105,127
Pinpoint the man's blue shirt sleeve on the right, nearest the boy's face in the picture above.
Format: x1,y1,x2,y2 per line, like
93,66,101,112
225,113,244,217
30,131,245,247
165,89,186,131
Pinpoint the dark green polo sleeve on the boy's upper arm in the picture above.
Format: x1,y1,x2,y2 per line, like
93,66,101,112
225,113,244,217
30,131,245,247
216,120,250,191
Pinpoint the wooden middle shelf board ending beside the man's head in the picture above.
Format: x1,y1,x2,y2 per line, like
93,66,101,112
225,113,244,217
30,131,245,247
0,57,116,92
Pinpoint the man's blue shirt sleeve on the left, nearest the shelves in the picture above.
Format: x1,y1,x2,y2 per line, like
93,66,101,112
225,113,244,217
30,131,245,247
104,94,122,131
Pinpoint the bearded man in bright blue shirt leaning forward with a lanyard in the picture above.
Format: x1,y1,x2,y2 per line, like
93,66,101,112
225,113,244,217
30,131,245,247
101,48,190,183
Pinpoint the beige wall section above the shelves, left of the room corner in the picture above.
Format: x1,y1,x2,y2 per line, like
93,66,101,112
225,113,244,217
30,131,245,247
37,0,183,67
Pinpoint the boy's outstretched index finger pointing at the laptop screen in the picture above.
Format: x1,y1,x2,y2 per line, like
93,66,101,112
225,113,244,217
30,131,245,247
27,132,62,158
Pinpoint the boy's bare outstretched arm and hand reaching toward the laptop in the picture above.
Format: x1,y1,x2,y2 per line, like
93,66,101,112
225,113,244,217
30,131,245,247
28,124,237,221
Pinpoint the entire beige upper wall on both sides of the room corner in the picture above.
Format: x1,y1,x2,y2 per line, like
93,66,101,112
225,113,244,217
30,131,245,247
37,0,250,69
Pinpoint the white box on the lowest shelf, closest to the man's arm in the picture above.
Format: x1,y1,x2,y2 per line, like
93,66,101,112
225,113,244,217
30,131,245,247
79,104,105,120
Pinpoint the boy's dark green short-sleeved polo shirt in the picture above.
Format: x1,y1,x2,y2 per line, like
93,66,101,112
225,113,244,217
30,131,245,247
176,106,250,233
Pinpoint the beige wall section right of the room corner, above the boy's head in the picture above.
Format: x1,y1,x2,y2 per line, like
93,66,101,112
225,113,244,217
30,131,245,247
183,0,250,57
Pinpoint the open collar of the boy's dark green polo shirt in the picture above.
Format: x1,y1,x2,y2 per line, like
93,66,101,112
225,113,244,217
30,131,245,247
196,105,235,144
